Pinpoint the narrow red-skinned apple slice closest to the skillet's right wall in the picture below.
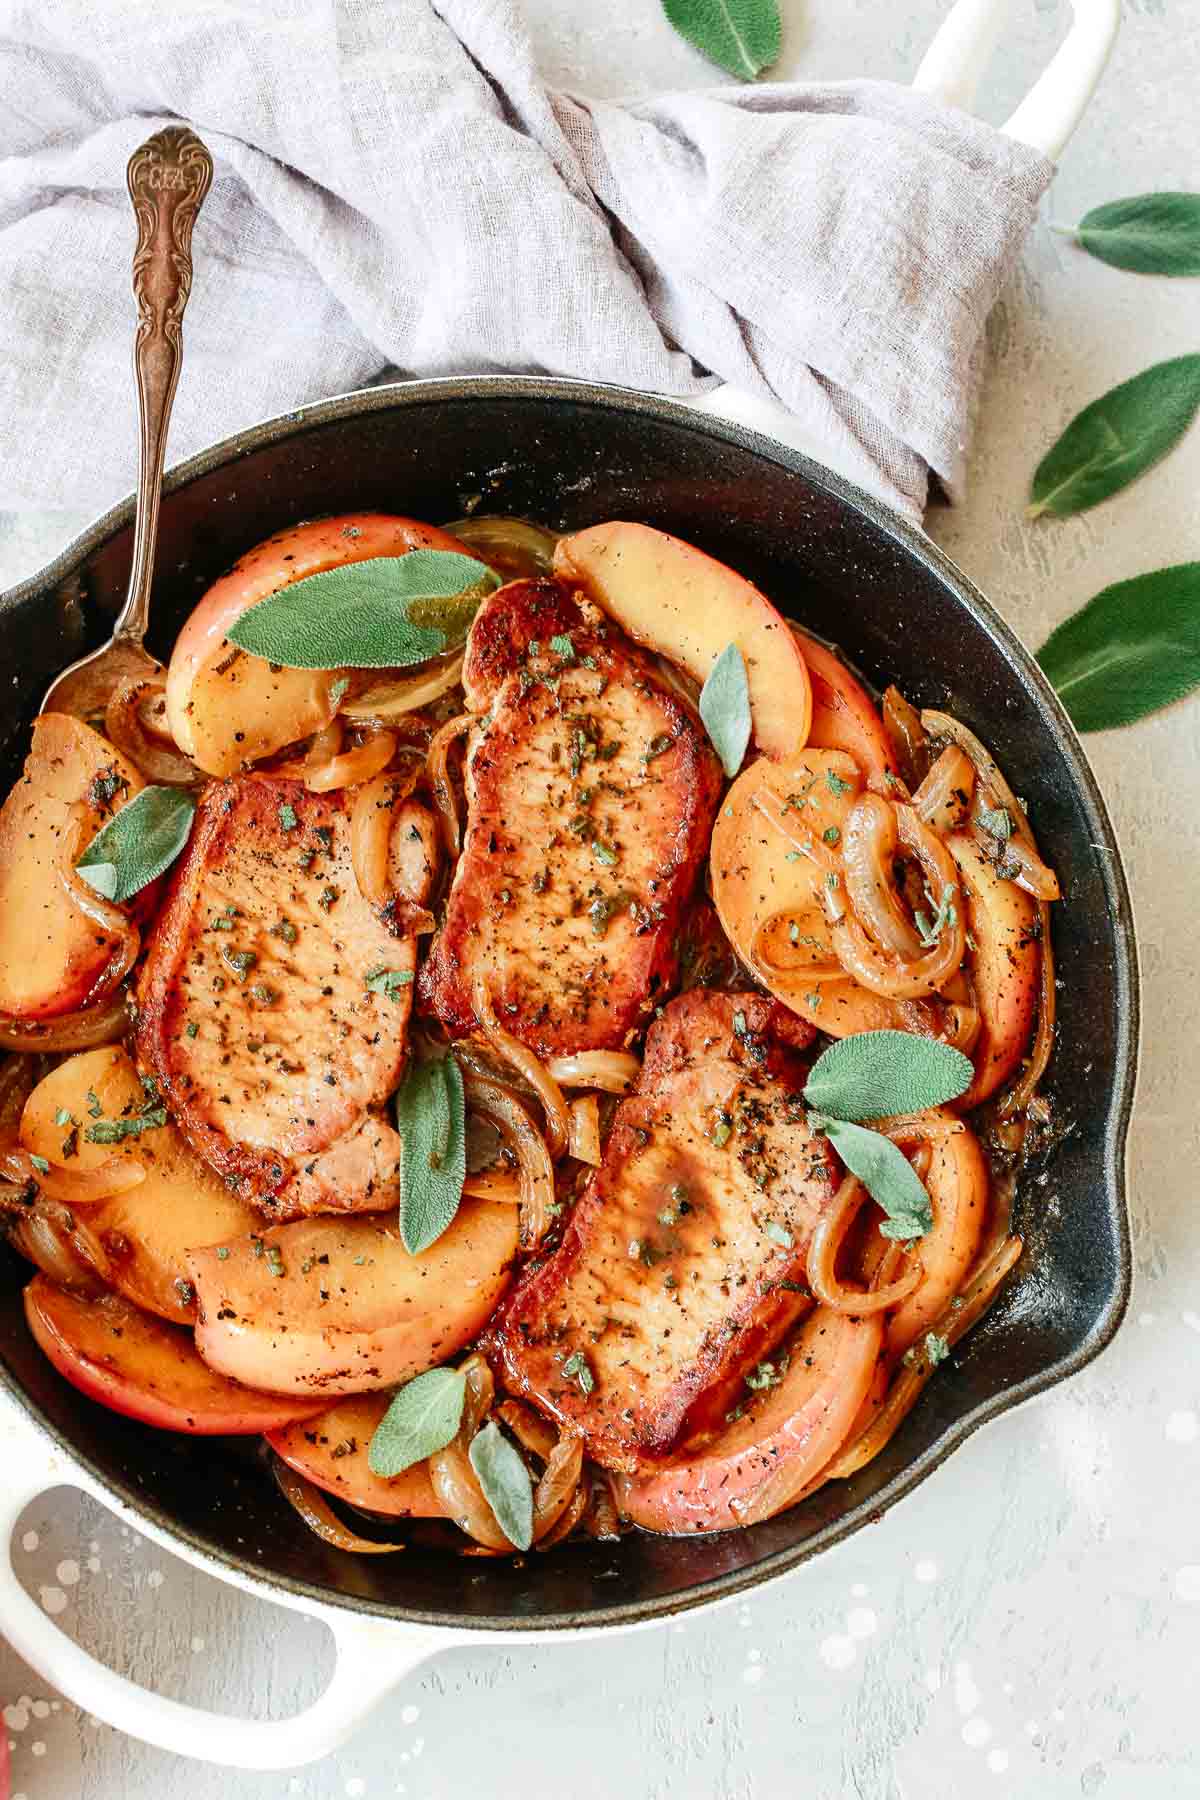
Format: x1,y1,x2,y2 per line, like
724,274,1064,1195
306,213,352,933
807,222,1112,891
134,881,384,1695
946,832,1042,1112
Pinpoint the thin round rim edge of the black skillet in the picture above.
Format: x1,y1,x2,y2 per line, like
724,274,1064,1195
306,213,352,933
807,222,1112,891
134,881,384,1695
0,376,1141,1638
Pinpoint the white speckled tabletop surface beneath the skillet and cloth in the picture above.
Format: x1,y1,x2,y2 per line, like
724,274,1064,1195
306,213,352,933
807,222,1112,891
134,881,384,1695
0,0,1200,1800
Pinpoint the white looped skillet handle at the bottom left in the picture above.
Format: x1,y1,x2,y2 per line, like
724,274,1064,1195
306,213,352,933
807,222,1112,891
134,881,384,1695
0,1408,462,1769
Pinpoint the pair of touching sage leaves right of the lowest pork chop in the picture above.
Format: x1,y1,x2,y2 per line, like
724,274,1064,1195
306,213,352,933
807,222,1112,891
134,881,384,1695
804,1031,975,1240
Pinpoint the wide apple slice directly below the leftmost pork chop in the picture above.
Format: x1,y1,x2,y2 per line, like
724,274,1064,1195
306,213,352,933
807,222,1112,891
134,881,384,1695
187,1201,518,1395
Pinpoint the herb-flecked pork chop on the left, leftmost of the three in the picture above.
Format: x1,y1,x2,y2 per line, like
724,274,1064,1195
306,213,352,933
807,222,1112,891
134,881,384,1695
137,776,432,1219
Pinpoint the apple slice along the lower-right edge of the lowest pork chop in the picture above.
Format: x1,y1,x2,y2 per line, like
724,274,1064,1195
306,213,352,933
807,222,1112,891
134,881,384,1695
617,1307,883,1534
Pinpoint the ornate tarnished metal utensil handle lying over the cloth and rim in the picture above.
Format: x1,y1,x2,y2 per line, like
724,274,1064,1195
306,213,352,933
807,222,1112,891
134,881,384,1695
113,126,212,641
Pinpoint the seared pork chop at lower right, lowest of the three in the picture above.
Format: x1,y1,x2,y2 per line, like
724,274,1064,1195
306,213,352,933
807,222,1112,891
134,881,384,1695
488,988,837,1471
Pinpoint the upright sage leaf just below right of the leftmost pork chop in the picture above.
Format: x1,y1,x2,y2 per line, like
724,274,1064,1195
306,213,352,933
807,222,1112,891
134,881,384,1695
396,1057,466,1256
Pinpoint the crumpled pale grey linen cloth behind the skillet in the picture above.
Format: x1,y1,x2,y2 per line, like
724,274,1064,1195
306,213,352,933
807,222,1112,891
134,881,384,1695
0,0,1052,517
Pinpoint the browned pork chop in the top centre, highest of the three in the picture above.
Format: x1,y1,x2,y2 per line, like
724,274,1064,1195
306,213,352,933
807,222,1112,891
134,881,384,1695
419,580,721,1057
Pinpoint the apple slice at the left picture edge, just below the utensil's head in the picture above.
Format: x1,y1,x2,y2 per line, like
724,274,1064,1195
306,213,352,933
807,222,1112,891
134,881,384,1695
0,713,146,1019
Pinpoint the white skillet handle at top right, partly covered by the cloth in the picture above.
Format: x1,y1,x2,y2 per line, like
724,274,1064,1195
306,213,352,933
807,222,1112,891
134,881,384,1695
696,0,1121,450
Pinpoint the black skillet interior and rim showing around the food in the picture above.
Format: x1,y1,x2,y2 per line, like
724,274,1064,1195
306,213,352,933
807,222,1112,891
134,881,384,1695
0,378,1137,1631
